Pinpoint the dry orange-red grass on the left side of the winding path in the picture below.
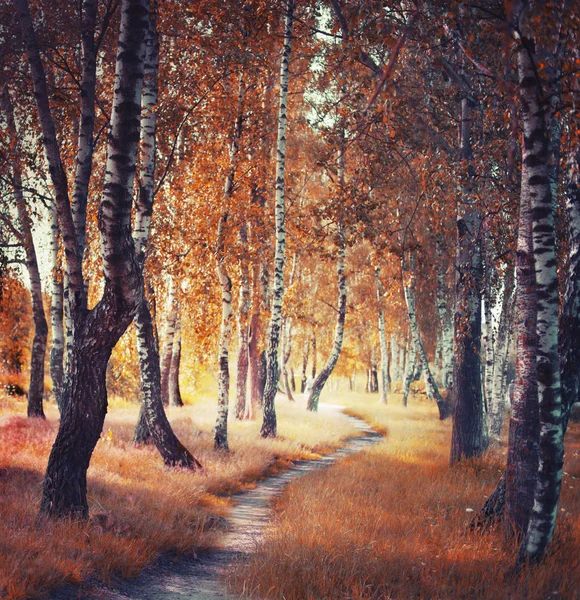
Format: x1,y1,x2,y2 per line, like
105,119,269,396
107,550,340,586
0,384,353,599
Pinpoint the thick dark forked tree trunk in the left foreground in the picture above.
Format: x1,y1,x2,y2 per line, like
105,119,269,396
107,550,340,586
16,0,149,517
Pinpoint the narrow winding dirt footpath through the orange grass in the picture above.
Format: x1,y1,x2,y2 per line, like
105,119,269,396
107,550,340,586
53,404,383,600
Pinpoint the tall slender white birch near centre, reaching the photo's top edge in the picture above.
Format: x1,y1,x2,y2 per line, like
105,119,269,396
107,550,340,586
260,0,294,438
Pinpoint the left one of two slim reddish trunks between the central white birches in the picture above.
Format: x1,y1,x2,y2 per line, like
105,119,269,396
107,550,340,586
236,222,252,420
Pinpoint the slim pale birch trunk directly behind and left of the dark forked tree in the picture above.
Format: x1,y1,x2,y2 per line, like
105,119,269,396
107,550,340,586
49,207,64,414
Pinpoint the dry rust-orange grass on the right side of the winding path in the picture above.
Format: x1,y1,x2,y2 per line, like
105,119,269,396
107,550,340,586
230,394,580,600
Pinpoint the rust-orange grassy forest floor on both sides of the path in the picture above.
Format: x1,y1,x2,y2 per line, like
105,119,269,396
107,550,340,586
0,382,580,600
